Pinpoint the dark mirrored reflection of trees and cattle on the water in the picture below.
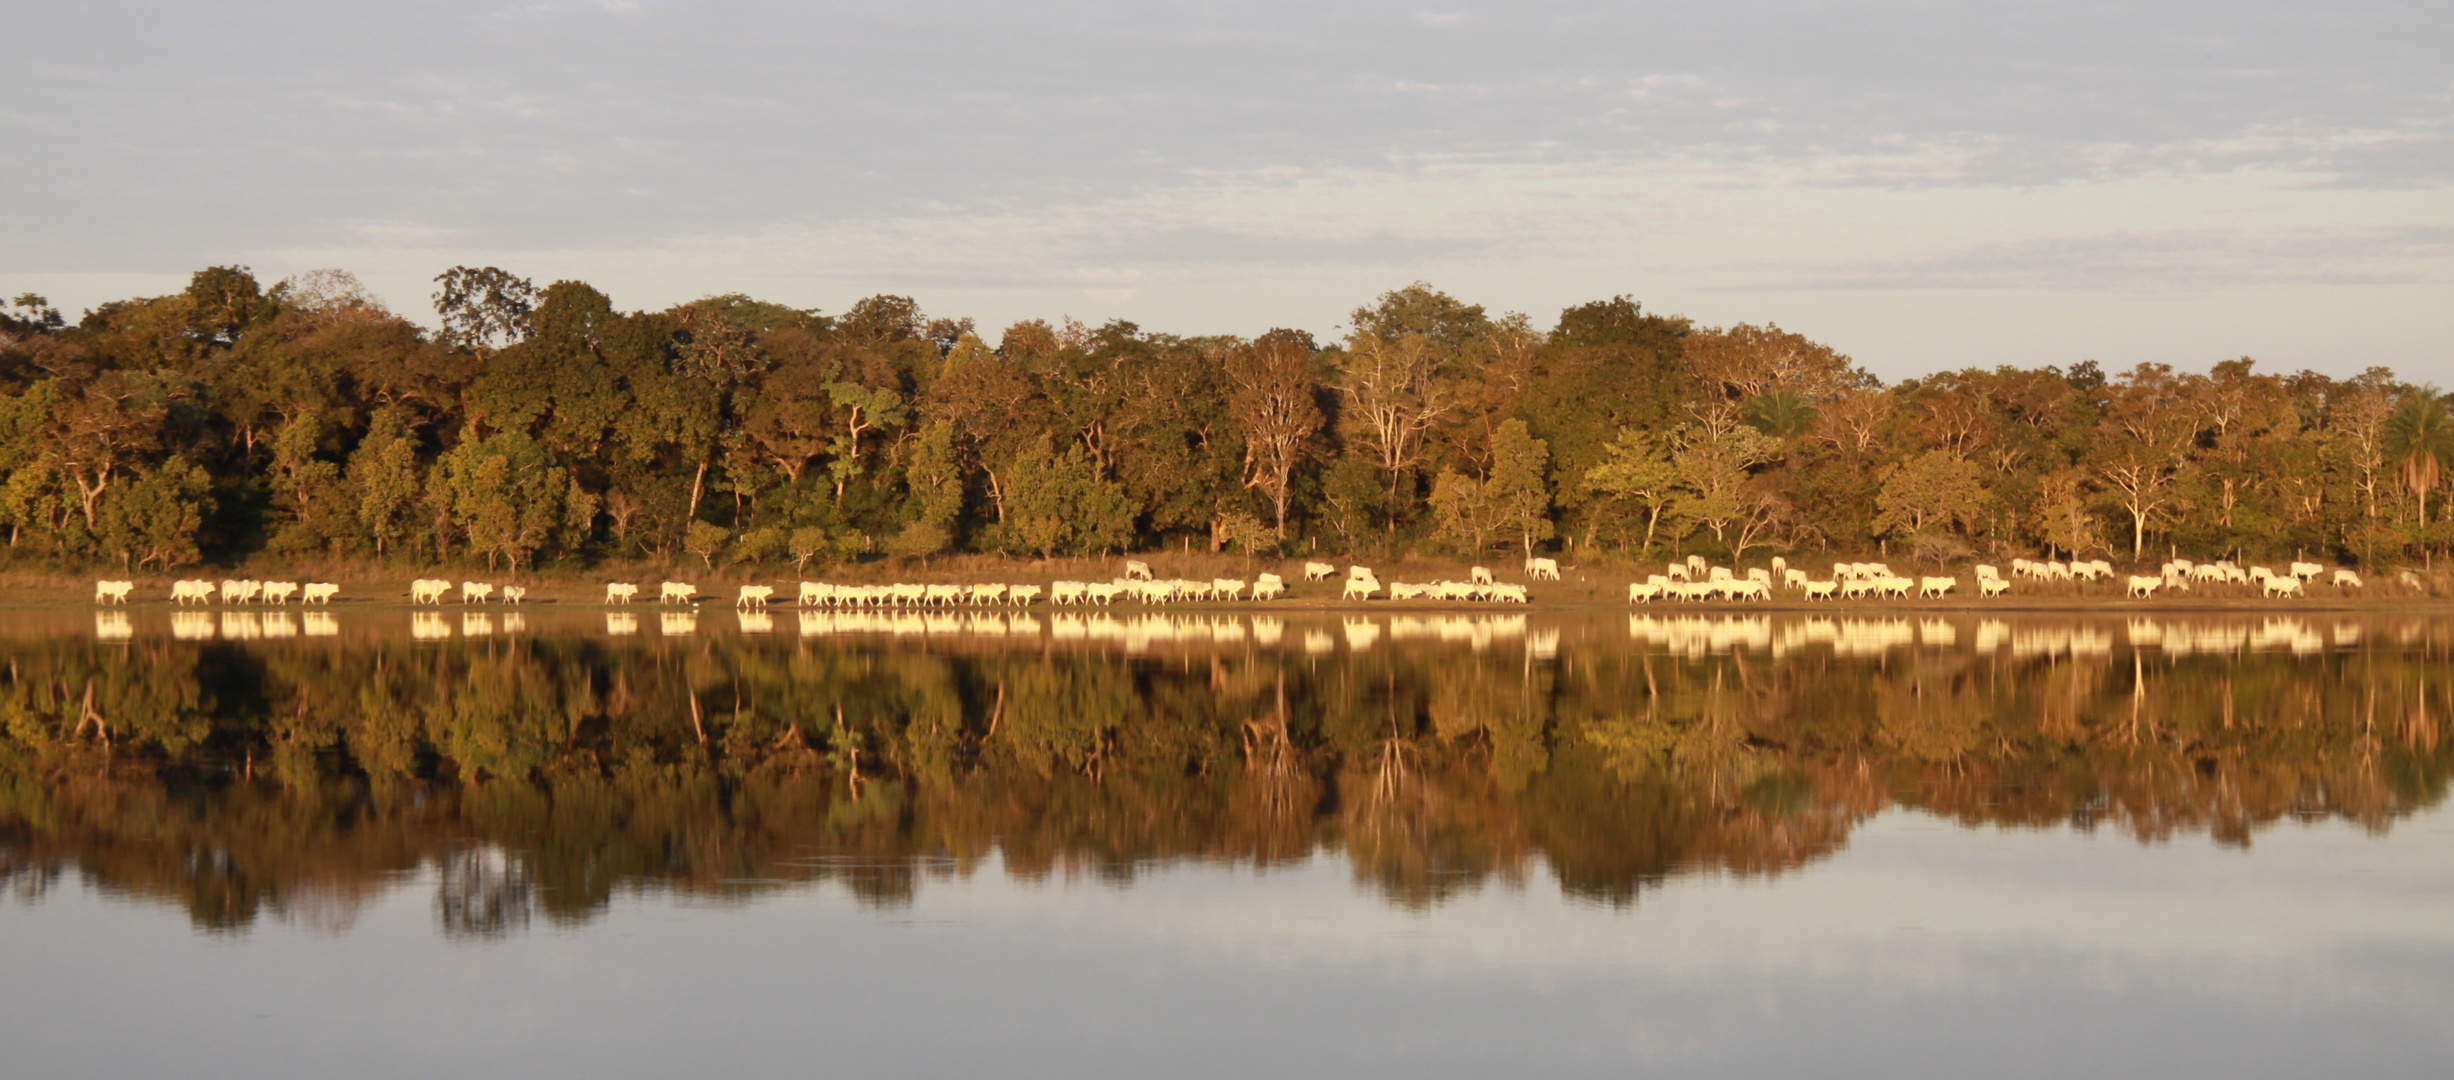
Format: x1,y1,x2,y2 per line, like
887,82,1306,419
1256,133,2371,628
0,611,2454,938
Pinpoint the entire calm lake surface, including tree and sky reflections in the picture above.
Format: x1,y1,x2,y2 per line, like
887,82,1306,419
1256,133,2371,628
0,609,2454,1078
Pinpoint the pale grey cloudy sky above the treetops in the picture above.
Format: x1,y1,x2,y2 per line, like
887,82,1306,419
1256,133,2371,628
0,0,2454,383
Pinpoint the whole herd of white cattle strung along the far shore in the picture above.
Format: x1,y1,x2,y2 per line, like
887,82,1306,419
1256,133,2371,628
93,555,2422,609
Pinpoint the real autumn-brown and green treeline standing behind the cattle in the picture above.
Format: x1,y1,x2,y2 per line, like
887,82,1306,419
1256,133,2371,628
0,268,2454,569
